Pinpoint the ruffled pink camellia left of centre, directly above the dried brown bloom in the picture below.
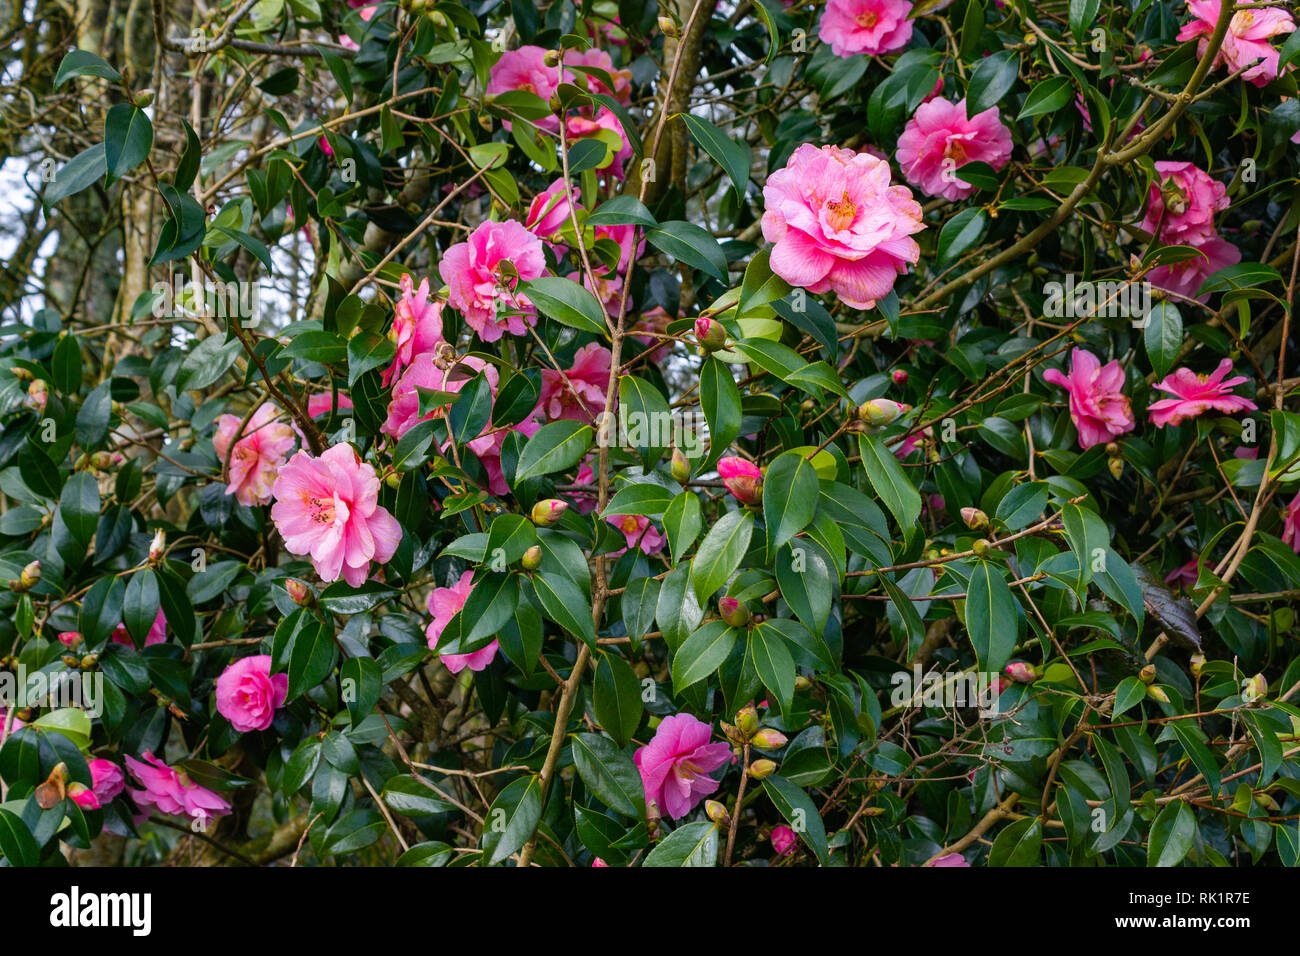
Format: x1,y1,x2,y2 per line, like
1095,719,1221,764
438,219,546,342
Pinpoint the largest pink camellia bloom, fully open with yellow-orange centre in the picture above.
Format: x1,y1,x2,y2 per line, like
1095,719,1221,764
763,143,926,308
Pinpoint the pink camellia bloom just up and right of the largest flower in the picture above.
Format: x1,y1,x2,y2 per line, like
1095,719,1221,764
894,96,1011,199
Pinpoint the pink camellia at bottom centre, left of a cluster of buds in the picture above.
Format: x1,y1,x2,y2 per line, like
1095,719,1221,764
632,714,731,819
